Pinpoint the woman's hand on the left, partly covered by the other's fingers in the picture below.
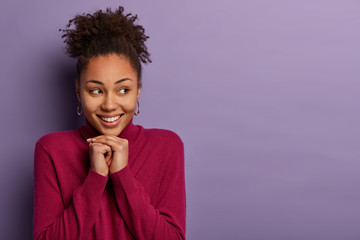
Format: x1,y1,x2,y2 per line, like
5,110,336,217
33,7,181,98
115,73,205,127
87,141,112,176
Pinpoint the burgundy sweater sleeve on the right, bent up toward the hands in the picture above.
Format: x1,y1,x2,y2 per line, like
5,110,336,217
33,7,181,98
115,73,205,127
110,138,186,240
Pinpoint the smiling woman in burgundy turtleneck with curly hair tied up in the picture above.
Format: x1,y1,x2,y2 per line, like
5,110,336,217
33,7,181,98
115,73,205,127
33,7,185,240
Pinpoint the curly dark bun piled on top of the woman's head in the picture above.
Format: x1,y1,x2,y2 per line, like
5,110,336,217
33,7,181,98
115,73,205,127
59,6,151,63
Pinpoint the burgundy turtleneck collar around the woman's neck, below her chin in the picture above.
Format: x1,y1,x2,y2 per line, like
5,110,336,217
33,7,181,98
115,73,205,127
79,119,138,141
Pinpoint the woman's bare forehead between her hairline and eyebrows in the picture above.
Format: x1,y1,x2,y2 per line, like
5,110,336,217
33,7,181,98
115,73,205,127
80,54,137,84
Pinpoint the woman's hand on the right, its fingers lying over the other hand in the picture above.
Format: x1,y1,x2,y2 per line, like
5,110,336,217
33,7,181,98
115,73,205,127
87,135,129,173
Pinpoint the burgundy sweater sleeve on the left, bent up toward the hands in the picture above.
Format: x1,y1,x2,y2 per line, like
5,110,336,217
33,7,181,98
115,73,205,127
33,142,108,240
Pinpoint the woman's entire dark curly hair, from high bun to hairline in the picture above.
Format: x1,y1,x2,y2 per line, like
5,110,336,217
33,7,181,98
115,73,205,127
59,6,151,87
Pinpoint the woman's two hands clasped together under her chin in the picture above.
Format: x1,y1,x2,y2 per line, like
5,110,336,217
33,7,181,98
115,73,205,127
87,135,129,176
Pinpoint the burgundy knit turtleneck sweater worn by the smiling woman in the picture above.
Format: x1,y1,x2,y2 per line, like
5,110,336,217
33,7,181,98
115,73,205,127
33,122,185,240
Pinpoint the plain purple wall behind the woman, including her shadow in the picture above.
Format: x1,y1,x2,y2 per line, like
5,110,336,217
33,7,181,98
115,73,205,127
0,0,360,240
